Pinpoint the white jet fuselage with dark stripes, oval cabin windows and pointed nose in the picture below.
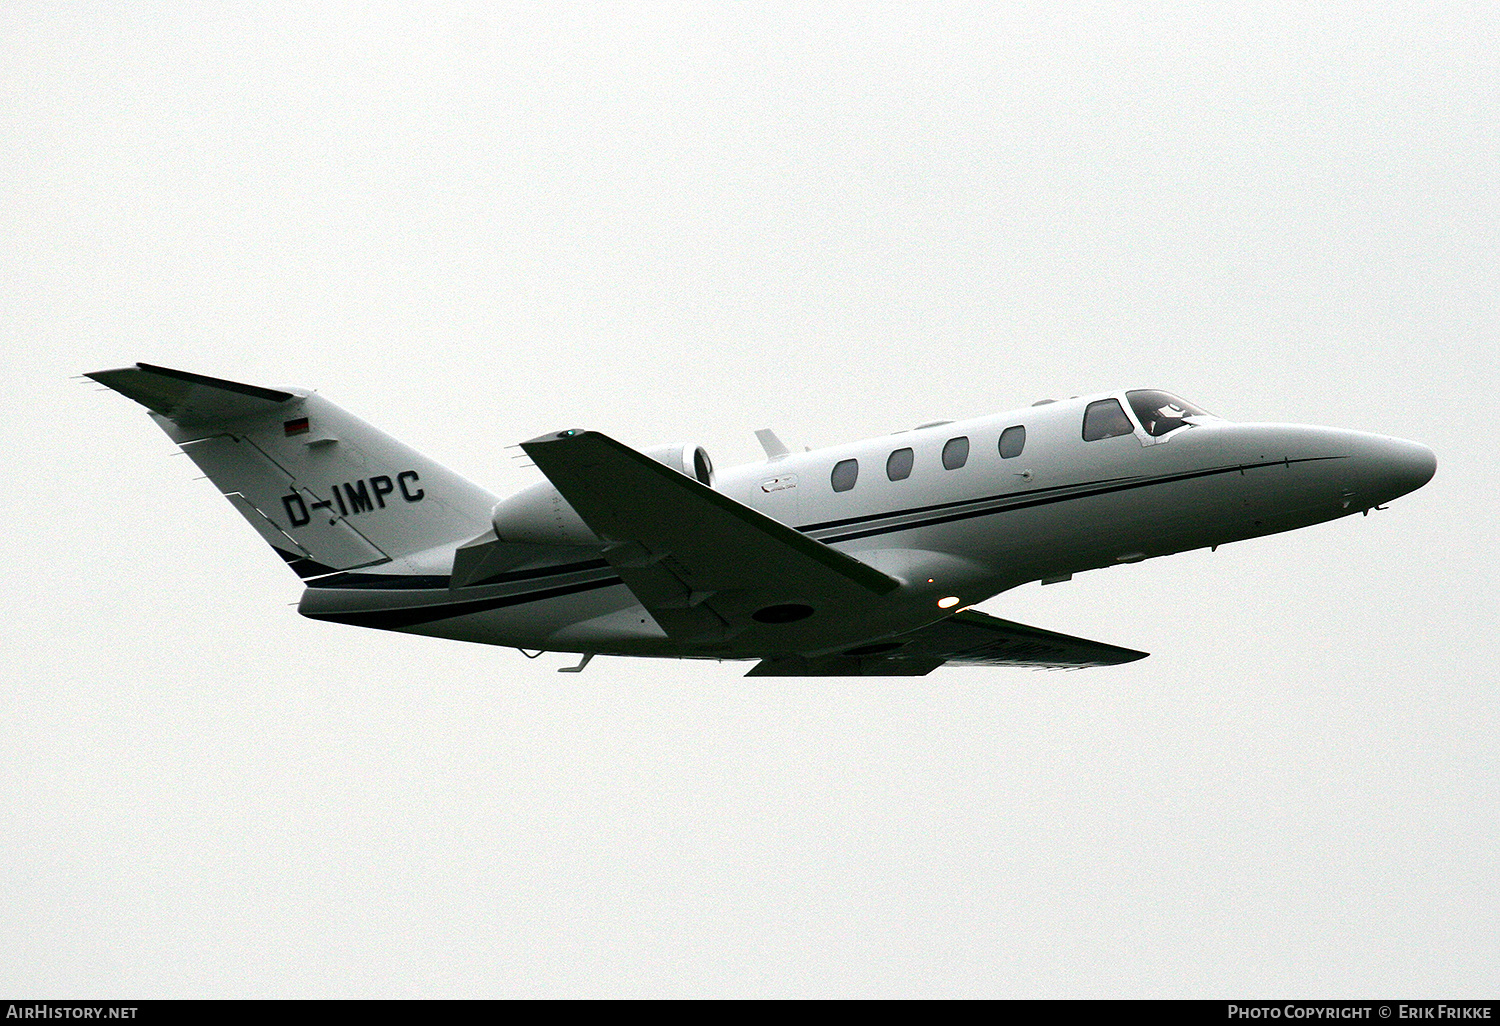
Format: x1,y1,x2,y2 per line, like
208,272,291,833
322,393,1436,659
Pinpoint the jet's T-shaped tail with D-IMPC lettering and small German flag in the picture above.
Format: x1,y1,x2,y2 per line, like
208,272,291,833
87,363,497,579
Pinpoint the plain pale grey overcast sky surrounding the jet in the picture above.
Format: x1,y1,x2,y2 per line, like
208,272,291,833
0,0,1500,998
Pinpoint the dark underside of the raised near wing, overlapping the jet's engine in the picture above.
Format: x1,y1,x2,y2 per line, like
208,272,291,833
521,431,900,642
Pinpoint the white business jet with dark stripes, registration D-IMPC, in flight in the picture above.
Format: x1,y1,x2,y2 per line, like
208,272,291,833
89,363,1437,677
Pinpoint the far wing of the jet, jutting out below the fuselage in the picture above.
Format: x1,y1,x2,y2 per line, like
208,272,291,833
746,609,1146,677
